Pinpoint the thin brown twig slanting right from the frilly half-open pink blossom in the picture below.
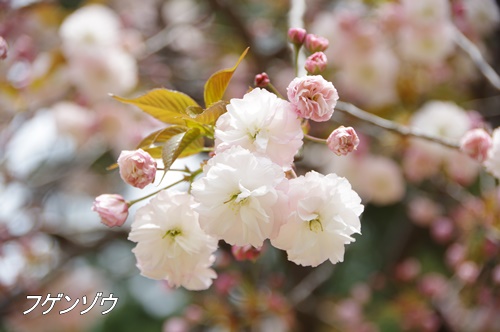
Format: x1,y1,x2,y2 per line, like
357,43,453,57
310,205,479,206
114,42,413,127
335,101,459,149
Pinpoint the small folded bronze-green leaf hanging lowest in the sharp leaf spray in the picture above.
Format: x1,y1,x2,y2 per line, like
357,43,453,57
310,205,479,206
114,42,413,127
162,128,203,171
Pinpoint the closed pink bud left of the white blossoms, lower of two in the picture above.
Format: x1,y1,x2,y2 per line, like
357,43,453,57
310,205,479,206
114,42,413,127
92,194,128,227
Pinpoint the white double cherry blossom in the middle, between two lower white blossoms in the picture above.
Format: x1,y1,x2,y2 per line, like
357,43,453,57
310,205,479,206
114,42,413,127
191,146,286,247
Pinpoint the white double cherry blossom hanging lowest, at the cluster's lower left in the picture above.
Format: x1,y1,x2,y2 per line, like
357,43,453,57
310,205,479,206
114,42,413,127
128,191,217,290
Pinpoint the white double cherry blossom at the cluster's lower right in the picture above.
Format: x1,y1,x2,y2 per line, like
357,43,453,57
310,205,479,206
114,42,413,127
271,171,363,267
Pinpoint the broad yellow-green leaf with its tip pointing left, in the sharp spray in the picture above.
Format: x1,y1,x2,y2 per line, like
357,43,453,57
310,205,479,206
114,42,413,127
113,89,199,125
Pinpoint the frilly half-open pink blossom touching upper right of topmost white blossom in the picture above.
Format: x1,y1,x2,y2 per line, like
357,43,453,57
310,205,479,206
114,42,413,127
287,75,339,122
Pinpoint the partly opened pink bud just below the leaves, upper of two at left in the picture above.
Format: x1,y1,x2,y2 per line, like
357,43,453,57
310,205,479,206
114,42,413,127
118,149,156,189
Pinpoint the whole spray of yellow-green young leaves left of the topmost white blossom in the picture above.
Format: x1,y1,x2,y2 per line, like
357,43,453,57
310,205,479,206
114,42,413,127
113,48,248,171
